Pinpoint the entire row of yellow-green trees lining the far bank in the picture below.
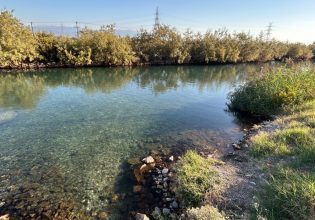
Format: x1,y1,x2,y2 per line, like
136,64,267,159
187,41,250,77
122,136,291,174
0,11,315,68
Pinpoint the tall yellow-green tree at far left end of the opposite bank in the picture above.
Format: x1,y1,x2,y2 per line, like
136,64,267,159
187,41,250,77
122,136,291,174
0,11,37,67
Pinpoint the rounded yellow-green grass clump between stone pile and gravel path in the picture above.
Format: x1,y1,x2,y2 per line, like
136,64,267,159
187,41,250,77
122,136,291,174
177,151,222,207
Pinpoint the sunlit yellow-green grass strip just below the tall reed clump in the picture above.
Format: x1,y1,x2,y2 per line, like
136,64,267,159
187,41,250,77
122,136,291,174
251,102,315,165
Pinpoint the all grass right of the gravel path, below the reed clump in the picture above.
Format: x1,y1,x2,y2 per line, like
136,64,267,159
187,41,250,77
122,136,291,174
251,101,315,219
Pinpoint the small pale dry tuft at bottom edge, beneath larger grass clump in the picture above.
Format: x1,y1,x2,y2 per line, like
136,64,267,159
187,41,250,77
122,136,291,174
186,205,225,220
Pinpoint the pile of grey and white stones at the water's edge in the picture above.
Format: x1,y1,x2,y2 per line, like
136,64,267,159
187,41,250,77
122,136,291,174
133,154,179,219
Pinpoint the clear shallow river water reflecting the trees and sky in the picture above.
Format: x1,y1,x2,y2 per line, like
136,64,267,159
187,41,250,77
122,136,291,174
0,65,259,218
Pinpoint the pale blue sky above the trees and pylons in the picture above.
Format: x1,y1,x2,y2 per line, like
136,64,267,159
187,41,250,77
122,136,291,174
0,0,315,43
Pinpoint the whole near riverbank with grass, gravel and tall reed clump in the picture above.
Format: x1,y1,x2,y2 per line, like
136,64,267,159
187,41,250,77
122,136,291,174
129,69,315,220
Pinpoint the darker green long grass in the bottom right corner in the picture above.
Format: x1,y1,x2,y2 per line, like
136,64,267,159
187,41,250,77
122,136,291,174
259,167,315,220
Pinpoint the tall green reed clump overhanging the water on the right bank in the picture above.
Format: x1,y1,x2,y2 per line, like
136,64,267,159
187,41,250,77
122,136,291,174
229,68,315,116
